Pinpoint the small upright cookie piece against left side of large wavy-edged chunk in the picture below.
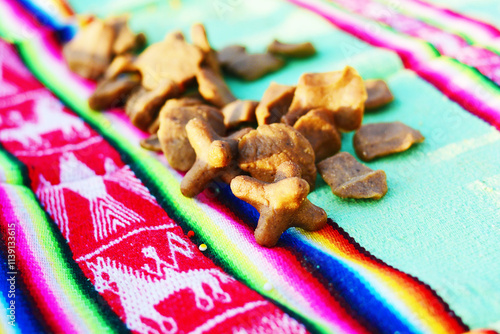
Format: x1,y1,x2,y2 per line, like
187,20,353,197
255,81,295,125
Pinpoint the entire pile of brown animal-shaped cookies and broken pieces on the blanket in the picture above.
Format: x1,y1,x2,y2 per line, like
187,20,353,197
64,18,424,247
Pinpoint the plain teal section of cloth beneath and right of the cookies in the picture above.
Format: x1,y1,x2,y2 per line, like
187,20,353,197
69,0,500,328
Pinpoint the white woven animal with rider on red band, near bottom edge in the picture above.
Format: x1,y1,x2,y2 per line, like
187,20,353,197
87,241,233,333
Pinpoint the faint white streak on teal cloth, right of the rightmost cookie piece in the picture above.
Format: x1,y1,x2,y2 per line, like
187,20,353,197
428,130,500,163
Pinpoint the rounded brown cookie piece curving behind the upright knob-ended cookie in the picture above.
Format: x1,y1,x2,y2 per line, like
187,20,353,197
158,99,226,172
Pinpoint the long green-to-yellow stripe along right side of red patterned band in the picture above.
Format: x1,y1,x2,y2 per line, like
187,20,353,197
17,41,331,332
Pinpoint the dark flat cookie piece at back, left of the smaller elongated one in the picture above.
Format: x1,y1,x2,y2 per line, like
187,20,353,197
217,45,285,81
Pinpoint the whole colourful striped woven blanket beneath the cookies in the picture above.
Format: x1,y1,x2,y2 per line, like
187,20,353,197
0,0,500,333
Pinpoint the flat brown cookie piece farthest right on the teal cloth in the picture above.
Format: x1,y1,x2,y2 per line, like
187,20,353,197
353,122,425,161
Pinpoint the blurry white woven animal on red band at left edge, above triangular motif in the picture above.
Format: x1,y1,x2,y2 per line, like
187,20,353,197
0,94,91,146
